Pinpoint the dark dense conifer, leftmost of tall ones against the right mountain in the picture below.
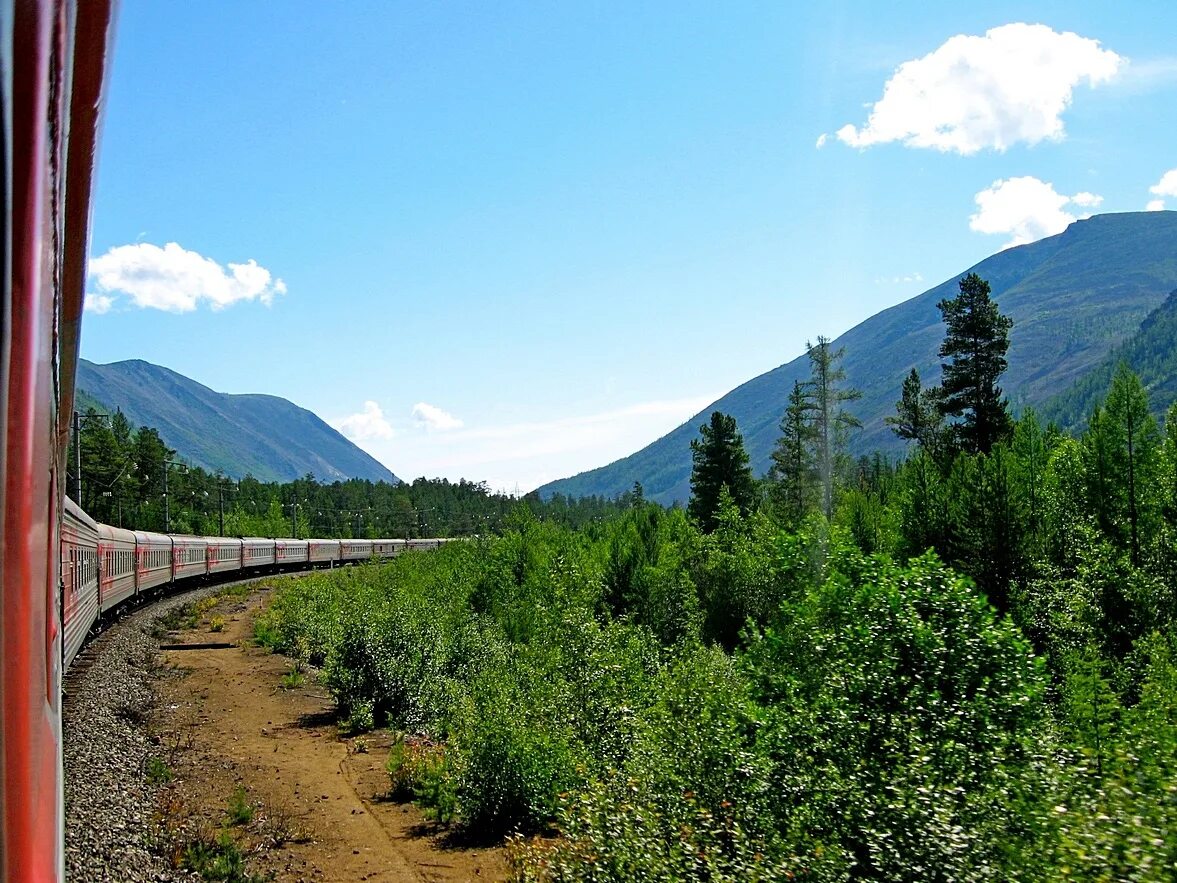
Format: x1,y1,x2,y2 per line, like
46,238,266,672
687,411,756,533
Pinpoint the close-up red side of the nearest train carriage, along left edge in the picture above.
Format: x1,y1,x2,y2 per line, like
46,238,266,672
0,0,111,882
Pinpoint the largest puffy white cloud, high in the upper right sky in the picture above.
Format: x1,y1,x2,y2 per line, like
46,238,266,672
837,22,1125,155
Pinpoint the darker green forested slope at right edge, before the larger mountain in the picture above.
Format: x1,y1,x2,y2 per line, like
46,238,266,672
1042,291,1177,430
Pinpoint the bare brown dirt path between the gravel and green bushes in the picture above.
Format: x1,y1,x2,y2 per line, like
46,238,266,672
153,587,506,883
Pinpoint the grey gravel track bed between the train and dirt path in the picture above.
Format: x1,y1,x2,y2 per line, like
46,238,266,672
62,586,224,883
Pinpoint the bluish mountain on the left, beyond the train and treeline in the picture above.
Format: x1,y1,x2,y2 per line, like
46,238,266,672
78,359,400,483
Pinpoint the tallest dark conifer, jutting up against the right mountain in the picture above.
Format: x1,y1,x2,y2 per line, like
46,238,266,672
937,273,1013,453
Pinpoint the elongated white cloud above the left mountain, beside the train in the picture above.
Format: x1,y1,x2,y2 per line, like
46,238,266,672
89,243,286,313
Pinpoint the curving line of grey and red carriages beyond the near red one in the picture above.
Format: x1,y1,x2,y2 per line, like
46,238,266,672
60,497,450,669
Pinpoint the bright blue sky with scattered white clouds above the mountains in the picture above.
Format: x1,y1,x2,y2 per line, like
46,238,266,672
82,0,1177,491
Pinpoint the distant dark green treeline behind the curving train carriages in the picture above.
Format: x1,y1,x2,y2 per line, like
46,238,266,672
67,409,630,538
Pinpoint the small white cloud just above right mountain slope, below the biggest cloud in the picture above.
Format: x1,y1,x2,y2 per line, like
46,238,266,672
969,175,1103,248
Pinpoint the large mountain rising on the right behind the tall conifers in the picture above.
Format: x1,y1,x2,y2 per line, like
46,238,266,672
539,212,1177,504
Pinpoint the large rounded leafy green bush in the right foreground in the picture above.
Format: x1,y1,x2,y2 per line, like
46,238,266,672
744,553,1051,881
